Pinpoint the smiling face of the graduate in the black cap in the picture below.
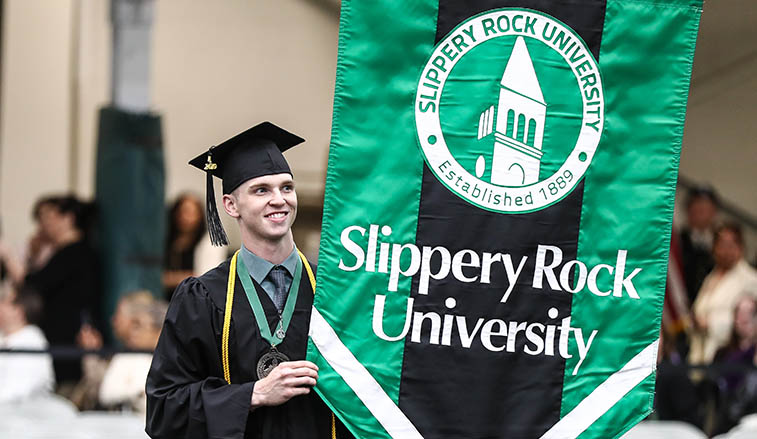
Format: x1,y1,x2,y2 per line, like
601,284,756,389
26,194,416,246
224,173,297,243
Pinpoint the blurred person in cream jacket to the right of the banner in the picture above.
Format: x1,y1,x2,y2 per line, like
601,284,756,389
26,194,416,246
689,223,757,364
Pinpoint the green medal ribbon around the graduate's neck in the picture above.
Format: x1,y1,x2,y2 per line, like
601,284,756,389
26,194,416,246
237,253,302,347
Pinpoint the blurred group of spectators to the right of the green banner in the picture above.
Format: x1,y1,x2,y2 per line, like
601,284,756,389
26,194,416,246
654,187,757,435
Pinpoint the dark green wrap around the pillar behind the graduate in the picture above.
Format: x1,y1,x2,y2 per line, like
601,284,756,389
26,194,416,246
95,107,166,336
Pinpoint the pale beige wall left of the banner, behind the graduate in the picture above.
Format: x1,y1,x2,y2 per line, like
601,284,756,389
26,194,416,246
0,0,338,251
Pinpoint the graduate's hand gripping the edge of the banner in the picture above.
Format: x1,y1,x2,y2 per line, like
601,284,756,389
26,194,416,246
250,361,318,410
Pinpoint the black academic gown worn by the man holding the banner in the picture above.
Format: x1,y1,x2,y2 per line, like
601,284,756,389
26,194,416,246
146,260,341,439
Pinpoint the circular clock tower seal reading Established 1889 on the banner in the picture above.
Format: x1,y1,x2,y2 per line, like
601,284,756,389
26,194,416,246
415,8,604,213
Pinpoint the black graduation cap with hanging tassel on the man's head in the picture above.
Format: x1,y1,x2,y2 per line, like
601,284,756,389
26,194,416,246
189,122,305,245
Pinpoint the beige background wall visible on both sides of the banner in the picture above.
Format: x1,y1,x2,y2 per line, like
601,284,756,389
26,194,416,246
0,0,757,252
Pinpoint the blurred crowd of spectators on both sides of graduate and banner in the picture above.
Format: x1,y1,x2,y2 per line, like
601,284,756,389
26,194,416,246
0,188,757,434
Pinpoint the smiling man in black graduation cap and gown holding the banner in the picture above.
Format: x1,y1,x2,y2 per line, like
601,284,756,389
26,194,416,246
146,122,348,439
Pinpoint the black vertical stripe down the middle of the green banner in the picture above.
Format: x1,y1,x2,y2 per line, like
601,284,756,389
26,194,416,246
399,0,605,439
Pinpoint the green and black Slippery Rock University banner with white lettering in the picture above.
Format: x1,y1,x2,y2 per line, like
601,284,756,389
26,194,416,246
308,0,701,439
